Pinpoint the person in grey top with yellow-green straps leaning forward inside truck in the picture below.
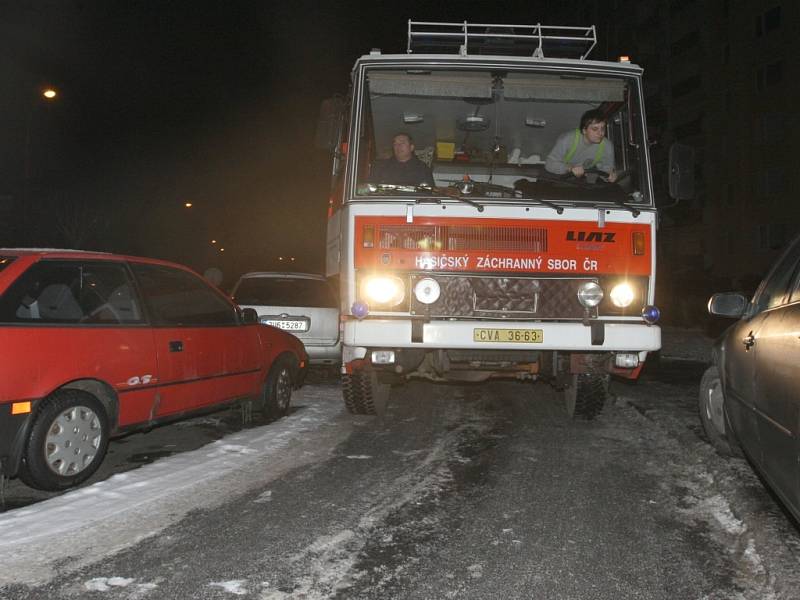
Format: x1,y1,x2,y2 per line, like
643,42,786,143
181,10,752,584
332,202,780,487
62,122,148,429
544,109,617,183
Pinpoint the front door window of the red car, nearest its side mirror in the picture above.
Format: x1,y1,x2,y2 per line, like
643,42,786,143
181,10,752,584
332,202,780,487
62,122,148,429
131,263,239,326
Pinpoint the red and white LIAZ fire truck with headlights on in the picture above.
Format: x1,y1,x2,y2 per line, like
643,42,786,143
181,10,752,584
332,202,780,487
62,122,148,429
318,21,693,419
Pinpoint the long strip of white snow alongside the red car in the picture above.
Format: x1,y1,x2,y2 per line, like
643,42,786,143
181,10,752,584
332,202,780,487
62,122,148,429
0,385,350,586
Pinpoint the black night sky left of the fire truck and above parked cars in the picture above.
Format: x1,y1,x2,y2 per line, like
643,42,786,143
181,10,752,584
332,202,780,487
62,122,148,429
0,0,561,284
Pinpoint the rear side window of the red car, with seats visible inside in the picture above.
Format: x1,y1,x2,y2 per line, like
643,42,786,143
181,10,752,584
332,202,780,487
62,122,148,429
0,260,142,325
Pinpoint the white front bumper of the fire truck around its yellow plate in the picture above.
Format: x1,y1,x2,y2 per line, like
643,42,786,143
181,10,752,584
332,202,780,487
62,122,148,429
343,319,661,352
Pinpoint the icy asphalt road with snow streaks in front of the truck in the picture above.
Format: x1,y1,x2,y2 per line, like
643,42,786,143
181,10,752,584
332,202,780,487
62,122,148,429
0,346,800,600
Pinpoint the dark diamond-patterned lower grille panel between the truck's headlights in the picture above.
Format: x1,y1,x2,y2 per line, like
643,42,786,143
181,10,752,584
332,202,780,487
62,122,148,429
410,273,597,319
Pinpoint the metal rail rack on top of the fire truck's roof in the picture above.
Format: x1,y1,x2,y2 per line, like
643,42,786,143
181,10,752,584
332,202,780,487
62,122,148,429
407,19,597,60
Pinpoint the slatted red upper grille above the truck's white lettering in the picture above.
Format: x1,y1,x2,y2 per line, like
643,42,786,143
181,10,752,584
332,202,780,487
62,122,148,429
378,225,547,252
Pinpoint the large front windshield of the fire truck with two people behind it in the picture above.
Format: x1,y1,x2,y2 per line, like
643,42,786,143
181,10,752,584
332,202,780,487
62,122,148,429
356,68,650,204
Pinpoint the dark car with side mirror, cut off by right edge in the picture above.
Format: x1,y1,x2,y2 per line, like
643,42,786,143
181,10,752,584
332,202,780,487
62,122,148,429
699,238,800,519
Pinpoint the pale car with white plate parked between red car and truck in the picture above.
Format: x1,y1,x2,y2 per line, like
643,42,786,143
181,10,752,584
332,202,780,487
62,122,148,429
233,272,342,365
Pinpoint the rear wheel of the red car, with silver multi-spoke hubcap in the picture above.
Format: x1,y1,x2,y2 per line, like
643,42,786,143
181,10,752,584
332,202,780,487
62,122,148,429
19,390,109,491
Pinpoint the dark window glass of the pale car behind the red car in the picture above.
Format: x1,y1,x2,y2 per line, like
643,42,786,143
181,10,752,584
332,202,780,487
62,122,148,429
234,277,338,308
